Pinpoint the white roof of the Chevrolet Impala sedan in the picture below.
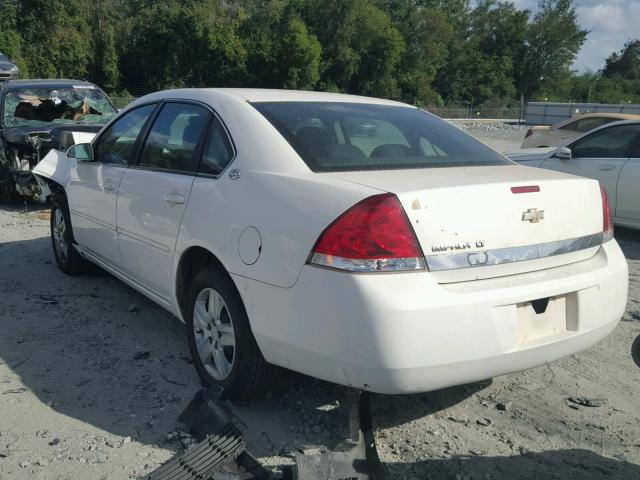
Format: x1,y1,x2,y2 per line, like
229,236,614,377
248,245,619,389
136,88,415,108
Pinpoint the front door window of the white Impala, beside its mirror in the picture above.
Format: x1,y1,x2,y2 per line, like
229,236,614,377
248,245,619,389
95,105,156,165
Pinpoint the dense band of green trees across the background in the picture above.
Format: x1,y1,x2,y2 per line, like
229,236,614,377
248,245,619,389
0,0,640,106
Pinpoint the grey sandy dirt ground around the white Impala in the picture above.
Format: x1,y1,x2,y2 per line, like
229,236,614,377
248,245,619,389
0,129,640,480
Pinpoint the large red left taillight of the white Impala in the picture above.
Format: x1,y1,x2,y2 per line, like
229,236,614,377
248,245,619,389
310,194,425,272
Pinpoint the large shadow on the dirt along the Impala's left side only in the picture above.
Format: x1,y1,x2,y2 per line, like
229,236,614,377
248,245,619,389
0,237,200,446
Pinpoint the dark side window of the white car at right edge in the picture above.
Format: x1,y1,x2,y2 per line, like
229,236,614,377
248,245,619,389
571,124,640,158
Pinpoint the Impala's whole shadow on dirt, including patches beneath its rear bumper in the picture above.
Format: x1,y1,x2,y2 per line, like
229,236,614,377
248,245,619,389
0,237,485,462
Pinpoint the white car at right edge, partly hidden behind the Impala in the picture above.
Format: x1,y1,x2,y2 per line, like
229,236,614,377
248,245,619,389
508,120,640,229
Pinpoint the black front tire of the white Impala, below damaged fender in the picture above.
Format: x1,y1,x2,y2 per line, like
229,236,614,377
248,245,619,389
50,199,89,275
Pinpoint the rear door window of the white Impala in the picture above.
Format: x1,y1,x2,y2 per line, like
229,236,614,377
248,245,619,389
140,103,210,173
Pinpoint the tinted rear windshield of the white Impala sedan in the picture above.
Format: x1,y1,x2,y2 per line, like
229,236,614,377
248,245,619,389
253,102,511,172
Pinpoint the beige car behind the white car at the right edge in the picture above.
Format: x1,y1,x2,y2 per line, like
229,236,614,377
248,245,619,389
521,113,640,148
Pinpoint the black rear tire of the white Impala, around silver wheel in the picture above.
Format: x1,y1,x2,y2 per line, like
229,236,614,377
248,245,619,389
185,268,275,403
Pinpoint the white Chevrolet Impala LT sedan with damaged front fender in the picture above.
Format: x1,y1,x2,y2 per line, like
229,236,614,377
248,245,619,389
36,89,627,399
